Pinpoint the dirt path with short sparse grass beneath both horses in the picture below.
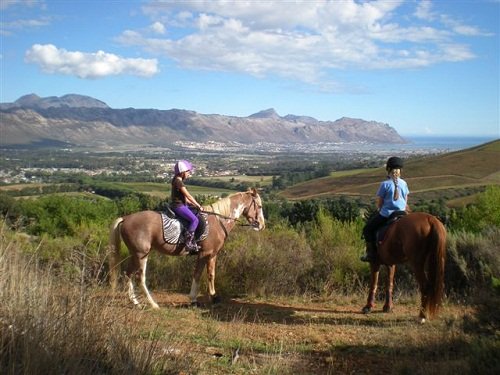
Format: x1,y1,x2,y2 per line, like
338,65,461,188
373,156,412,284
108,291,475,374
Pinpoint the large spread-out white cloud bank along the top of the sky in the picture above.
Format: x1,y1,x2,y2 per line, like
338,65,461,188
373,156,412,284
124,0,488,86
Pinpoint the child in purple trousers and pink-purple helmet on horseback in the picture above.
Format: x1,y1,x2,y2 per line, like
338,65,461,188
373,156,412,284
171,160,201,253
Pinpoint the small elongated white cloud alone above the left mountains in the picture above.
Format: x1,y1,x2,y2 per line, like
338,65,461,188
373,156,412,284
25,44,159,78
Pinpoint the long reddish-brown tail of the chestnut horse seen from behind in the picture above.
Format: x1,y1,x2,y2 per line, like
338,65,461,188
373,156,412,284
427,217,446,317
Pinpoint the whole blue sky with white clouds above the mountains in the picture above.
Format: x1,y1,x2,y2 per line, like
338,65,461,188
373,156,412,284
0,0,500,137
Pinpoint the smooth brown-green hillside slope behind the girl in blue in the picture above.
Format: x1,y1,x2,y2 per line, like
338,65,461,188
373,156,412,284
281,140,500,199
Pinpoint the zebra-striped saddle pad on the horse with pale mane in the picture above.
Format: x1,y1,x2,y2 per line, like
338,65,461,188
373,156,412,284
160,207,209,245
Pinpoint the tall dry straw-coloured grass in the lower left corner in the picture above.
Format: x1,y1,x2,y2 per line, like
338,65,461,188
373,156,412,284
0,225,193,374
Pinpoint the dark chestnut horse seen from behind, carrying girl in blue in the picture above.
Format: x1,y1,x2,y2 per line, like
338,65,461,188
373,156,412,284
363,212,446,323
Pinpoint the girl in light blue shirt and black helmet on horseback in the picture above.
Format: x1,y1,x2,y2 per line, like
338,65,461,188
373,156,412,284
361,156,410,262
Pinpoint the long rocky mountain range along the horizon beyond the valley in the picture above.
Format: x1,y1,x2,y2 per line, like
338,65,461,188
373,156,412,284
0,94,406,147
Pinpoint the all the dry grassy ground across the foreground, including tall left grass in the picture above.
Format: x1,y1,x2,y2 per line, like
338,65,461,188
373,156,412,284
0,233,499,374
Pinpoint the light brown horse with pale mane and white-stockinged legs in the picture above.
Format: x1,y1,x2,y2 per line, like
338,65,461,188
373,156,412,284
110,189,265,308
